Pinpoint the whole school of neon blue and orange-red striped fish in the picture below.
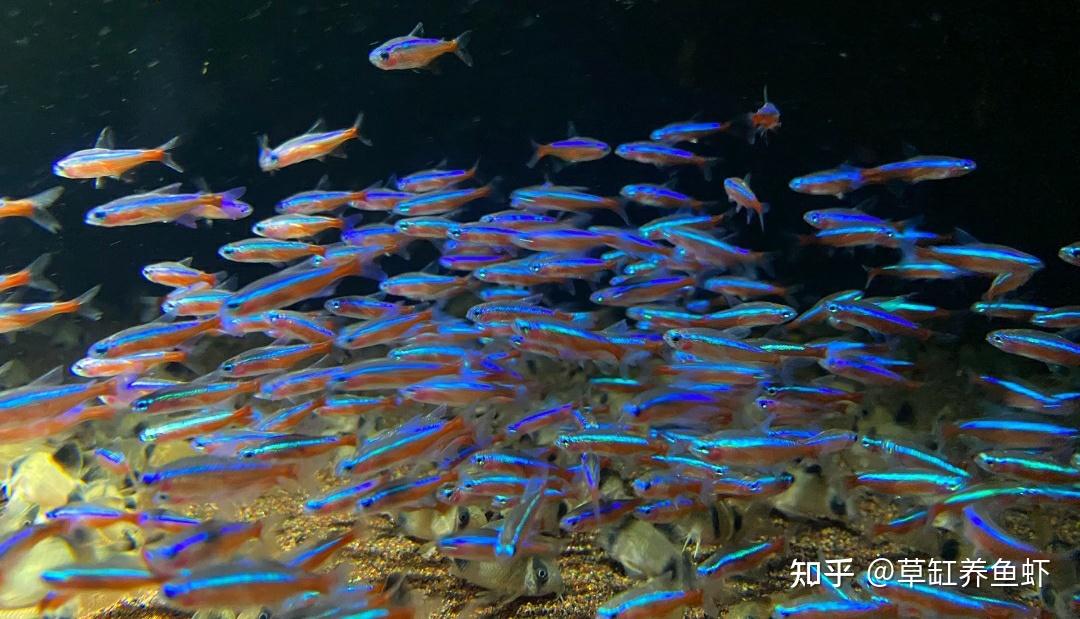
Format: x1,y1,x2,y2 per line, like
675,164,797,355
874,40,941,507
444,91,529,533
0,25,1080,619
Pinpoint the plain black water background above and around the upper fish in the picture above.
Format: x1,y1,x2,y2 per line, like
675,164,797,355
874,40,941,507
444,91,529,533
0,0,1080,309
